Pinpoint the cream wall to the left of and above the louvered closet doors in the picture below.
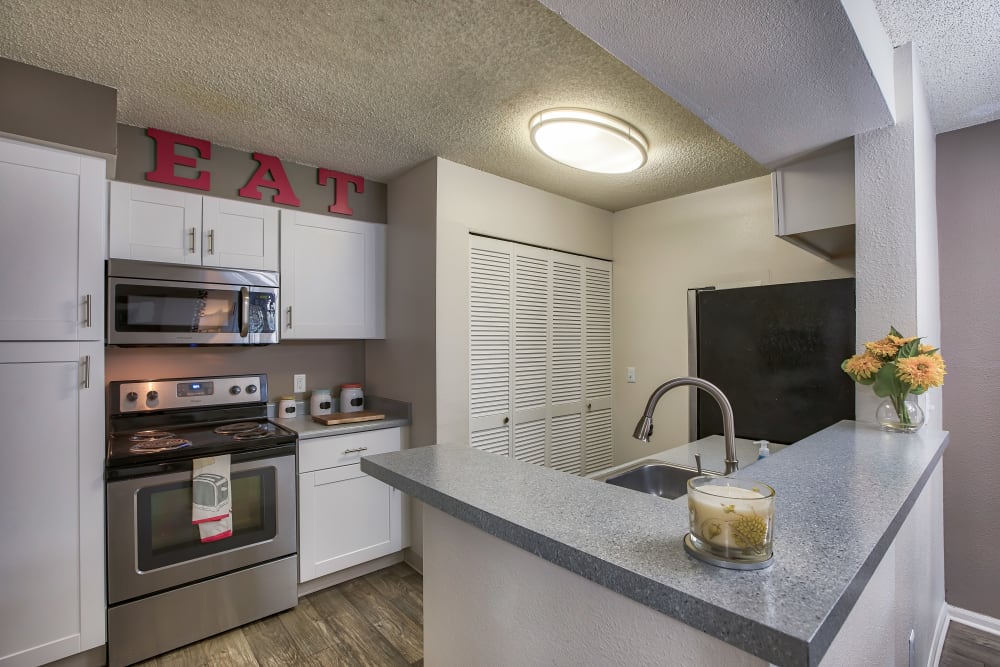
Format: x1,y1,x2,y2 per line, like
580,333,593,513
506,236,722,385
435,158,611,444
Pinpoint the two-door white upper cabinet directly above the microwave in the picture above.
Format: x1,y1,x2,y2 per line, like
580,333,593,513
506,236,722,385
109,181,278,271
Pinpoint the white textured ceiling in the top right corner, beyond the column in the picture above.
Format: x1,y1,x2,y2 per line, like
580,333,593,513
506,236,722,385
875,0,1000,132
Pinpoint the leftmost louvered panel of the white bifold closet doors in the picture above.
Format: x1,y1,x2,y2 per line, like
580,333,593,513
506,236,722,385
469,236,513,456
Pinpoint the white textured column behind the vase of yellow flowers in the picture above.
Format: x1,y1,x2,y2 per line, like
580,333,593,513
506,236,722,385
854,44,947,428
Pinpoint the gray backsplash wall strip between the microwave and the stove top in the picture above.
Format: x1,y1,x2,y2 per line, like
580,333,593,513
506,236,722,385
104,340,365,402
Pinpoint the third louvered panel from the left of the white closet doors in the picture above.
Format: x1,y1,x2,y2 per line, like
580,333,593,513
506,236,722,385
548,252,583,473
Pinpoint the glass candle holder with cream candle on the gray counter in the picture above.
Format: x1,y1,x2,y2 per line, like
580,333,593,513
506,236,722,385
687,476,774,564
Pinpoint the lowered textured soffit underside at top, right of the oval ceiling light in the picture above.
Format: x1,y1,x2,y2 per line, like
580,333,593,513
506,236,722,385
541,0,893,167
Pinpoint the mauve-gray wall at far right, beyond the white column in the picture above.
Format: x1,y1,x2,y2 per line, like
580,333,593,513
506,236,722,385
937,121,1000,618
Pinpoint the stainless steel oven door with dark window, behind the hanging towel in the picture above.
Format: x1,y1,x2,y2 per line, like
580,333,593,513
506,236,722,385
107,454,296,604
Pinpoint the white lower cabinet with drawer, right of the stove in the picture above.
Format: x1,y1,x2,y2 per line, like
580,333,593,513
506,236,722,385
299,428,404,582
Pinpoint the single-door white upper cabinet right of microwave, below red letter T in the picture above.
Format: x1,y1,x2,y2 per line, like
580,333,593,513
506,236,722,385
281,211,385,338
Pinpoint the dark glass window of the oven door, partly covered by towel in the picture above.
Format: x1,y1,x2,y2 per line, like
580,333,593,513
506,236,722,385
136,467,277,572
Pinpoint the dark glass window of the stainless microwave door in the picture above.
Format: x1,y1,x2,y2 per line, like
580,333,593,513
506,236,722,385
114,284,240,333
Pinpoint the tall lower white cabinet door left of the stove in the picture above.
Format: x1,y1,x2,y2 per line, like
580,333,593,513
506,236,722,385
0,341,106,667
